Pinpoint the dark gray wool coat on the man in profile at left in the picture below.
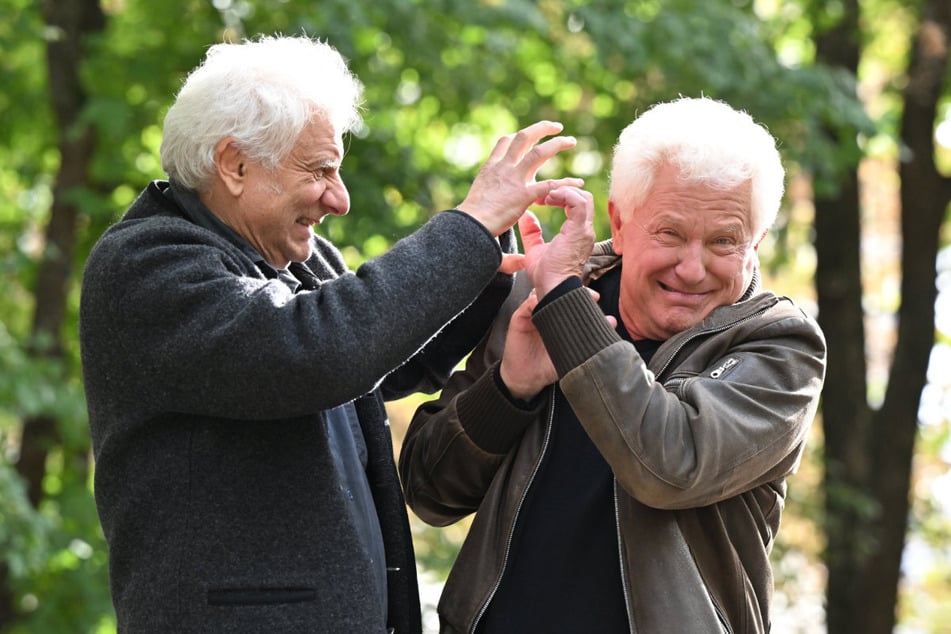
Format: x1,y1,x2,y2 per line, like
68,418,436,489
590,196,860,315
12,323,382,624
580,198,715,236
80,181,511,634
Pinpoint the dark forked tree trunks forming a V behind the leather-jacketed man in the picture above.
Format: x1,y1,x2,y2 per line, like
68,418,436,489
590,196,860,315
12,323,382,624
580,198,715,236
816,0,951,634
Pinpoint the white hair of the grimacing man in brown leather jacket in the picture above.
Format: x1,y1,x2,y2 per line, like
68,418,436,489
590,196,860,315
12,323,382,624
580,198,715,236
610,97,785,239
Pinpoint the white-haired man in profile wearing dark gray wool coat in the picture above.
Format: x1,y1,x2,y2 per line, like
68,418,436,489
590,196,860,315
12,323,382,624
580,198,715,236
80,37,581,634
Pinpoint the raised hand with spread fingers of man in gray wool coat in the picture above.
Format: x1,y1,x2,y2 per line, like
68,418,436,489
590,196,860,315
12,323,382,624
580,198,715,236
457,121,584,236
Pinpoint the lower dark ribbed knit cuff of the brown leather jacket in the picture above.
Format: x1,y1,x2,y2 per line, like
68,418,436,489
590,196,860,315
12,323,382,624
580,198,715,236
456,365,543,454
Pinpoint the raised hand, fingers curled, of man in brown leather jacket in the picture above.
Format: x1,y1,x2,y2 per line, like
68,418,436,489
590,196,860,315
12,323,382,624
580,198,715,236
518,187,594,298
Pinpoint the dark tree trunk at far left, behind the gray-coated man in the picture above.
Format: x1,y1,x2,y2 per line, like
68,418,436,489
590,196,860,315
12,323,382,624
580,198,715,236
0,0,105,628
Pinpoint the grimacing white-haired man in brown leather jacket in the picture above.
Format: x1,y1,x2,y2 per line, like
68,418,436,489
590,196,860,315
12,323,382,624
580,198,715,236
400,98,825,634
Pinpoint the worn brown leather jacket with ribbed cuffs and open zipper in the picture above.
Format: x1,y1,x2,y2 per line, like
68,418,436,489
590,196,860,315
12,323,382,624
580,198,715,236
400,243,826,634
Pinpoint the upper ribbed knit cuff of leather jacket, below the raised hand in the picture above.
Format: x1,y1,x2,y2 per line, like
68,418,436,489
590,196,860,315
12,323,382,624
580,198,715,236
532,288,621,377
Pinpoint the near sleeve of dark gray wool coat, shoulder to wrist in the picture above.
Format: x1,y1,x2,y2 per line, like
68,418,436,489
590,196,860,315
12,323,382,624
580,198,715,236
80,211,500,420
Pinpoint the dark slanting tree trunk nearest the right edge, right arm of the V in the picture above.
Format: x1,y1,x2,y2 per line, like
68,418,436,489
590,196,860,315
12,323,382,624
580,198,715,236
856,0,951,634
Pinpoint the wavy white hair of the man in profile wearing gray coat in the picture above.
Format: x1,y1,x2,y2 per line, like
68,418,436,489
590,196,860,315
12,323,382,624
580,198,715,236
161,35,363,191
